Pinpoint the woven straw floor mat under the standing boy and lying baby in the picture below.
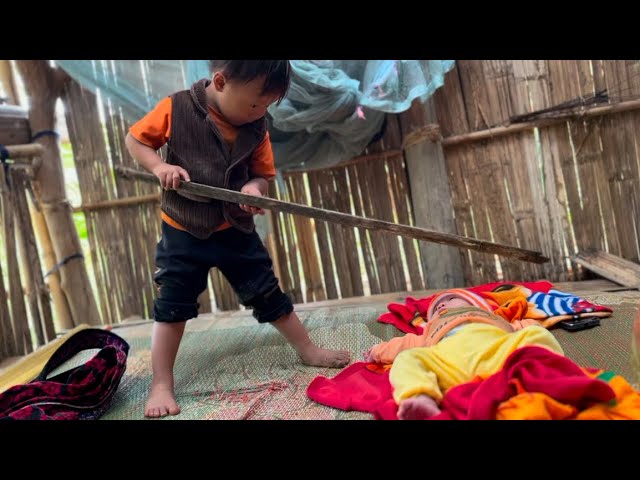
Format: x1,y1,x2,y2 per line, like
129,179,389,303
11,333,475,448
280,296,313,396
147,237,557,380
18,294,638,420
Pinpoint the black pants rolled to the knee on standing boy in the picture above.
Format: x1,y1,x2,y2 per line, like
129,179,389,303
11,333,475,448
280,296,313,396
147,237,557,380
154,222,293,323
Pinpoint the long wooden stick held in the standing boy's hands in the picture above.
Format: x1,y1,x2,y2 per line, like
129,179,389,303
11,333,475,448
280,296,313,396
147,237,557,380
115,167,549,263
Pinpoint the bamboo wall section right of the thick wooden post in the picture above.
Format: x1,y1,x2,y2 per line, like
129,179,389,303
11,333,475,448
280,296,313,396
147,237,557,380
435,60,640,284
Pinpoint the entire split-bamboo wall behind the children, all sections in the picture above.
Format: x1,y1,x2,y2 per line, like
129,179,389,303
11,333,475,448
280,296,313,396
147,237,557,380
5,60,640,342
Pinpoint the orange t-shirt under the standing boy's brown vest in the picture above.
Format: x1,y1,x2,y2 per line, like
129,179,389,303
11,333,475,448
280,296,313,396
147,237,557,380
129,97,276,232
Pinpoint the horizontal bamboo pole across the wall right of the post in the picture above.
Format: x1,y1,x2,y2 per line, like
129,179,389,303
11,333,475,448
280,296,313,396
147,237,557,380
442,95,640,147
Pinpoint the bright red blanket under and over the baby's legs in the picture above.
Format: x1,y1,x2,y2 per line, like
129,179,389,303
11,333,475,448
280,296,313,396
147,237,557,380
307,346,640,420
